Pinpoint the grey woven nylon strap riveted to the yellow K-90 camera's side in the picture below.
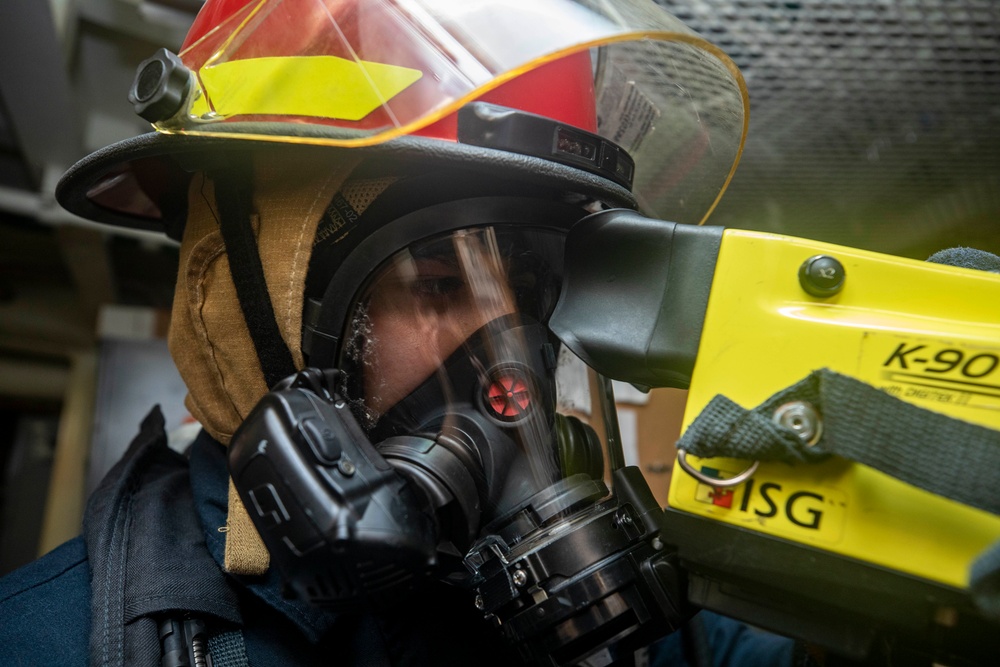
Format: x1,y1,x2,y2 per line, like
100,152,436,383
677,369,1000,514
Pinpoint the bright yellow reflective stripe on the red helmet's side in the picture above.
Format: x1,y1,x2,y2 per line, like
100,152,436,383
191,56,423,120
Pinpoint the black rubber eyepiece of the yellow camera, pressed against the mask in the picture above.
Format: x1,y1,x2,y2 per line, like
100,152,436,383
549,209,724,389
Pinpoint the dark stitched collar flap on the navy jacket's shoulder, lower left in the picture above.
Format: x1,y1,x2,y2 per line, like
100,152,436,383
84,407,242,667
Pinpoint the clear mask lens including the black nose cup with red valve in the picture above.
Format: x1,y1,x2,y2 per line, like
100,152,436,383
341,227,588,519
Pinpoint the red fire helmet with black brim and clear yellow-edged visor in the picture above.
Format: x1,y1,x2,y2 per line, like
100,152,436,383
57,0,748,237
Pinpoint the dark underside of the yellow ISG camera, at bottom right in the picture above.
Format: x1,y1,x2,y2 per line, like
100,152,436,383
662,508,1000,667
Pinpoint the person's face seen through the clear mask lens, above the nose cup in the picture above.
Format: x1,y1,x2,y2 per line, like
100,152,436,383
340,227,562,427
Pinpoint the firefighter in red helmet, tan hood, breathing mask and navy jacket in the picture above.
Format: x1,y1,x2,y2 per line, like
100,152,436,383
0,0,791,667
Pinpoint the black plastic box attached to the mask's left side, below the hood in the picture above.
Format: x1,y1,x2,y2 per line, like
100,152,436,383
229,378,438,607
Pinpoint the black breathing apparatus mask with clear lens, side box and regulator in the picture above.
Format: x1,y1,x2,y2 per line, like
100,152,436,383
230,197,685,664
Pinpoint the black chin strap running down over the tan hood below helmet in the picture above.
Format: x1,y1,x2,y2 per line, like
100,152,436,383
212,162,295,388
